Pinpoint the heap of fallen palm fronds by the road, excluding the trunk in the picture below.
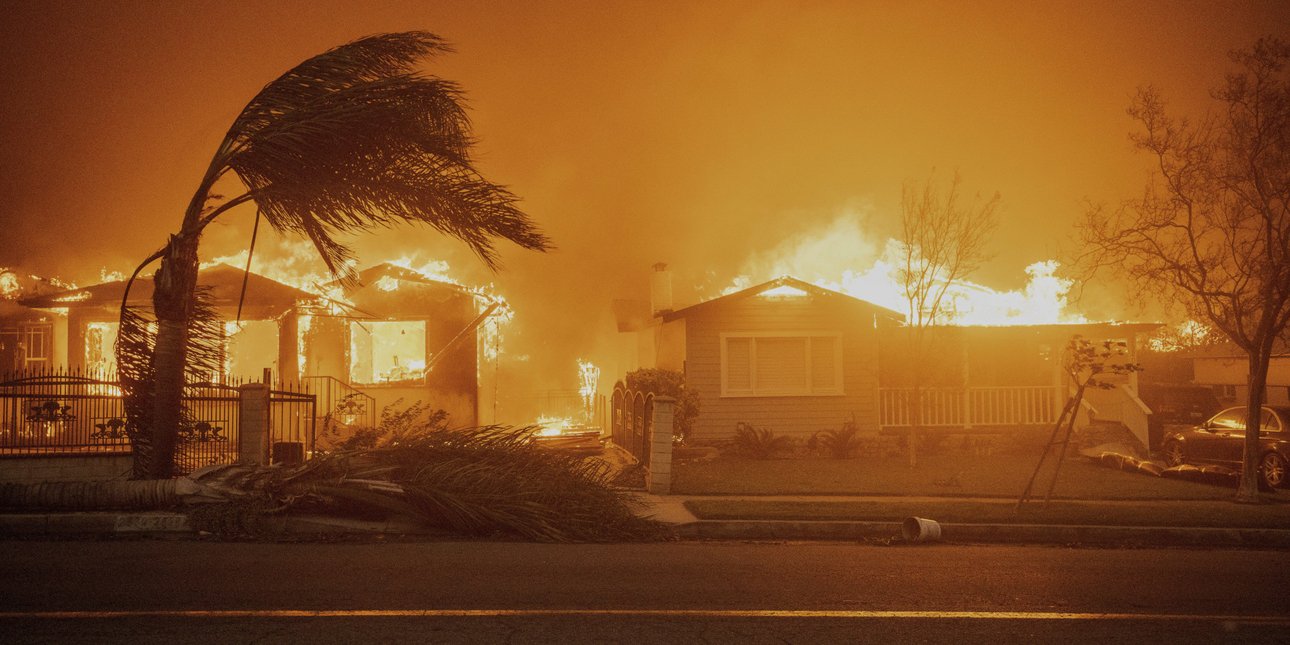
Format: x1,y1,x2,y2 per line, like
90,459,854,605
268,426,660,542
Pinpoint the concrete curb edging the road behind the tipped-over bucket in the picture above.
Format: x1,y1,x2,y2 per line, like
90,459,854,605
676,520,1290,550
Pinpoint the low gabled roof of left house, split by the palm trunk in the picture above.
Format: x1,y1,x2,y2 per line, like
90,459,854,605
22,264,316,308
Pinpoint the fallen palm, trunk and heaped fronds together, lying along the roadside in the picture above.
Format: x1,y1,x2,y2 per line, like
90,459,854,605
0,424,666,542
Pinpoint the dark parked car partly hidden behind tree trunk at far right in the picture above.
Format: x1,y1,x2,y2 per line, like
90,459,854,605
1164,405,1290,488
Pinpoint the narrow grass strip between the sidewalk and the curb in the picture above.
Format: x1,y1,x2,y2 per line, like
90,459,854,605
685,498,1290,529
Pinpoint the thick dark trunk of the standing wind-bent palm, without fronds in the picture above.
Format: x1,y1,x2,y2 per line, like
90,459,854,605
147,232,197,477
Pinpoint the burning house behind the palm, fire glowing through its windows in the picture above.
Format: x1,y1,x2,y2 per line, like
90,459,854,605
9,263,502,443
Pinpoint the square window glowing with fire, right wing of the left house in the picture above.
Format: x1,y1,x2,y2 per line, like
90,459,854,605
350,320,426,384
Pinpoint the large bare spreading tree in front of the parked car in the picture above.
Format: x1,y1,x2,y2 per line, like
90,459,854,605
1081,37,1290,502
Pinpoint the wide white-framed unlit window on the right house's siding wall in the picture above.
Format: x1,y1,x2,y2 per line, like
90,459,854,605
721,333,842,396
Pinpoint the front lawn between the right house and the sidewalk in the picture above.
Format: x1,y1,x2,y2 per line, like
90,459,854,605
672,452,1235,502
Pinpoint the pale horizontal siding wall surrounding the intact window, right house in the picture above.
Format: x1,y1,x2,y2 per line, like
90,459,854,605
684,297,878,441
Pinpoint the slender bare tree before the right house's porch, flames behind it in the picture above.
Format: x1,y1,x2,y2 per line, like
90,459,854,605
899,172,1000,467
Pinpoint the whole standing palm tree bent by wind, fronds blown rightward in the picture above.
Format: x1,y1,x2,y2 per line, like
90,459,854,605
117,32,550,477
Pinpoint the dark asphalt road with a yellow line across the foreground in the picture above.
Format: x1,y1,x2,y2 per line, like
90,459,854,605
0,541,1290,644
